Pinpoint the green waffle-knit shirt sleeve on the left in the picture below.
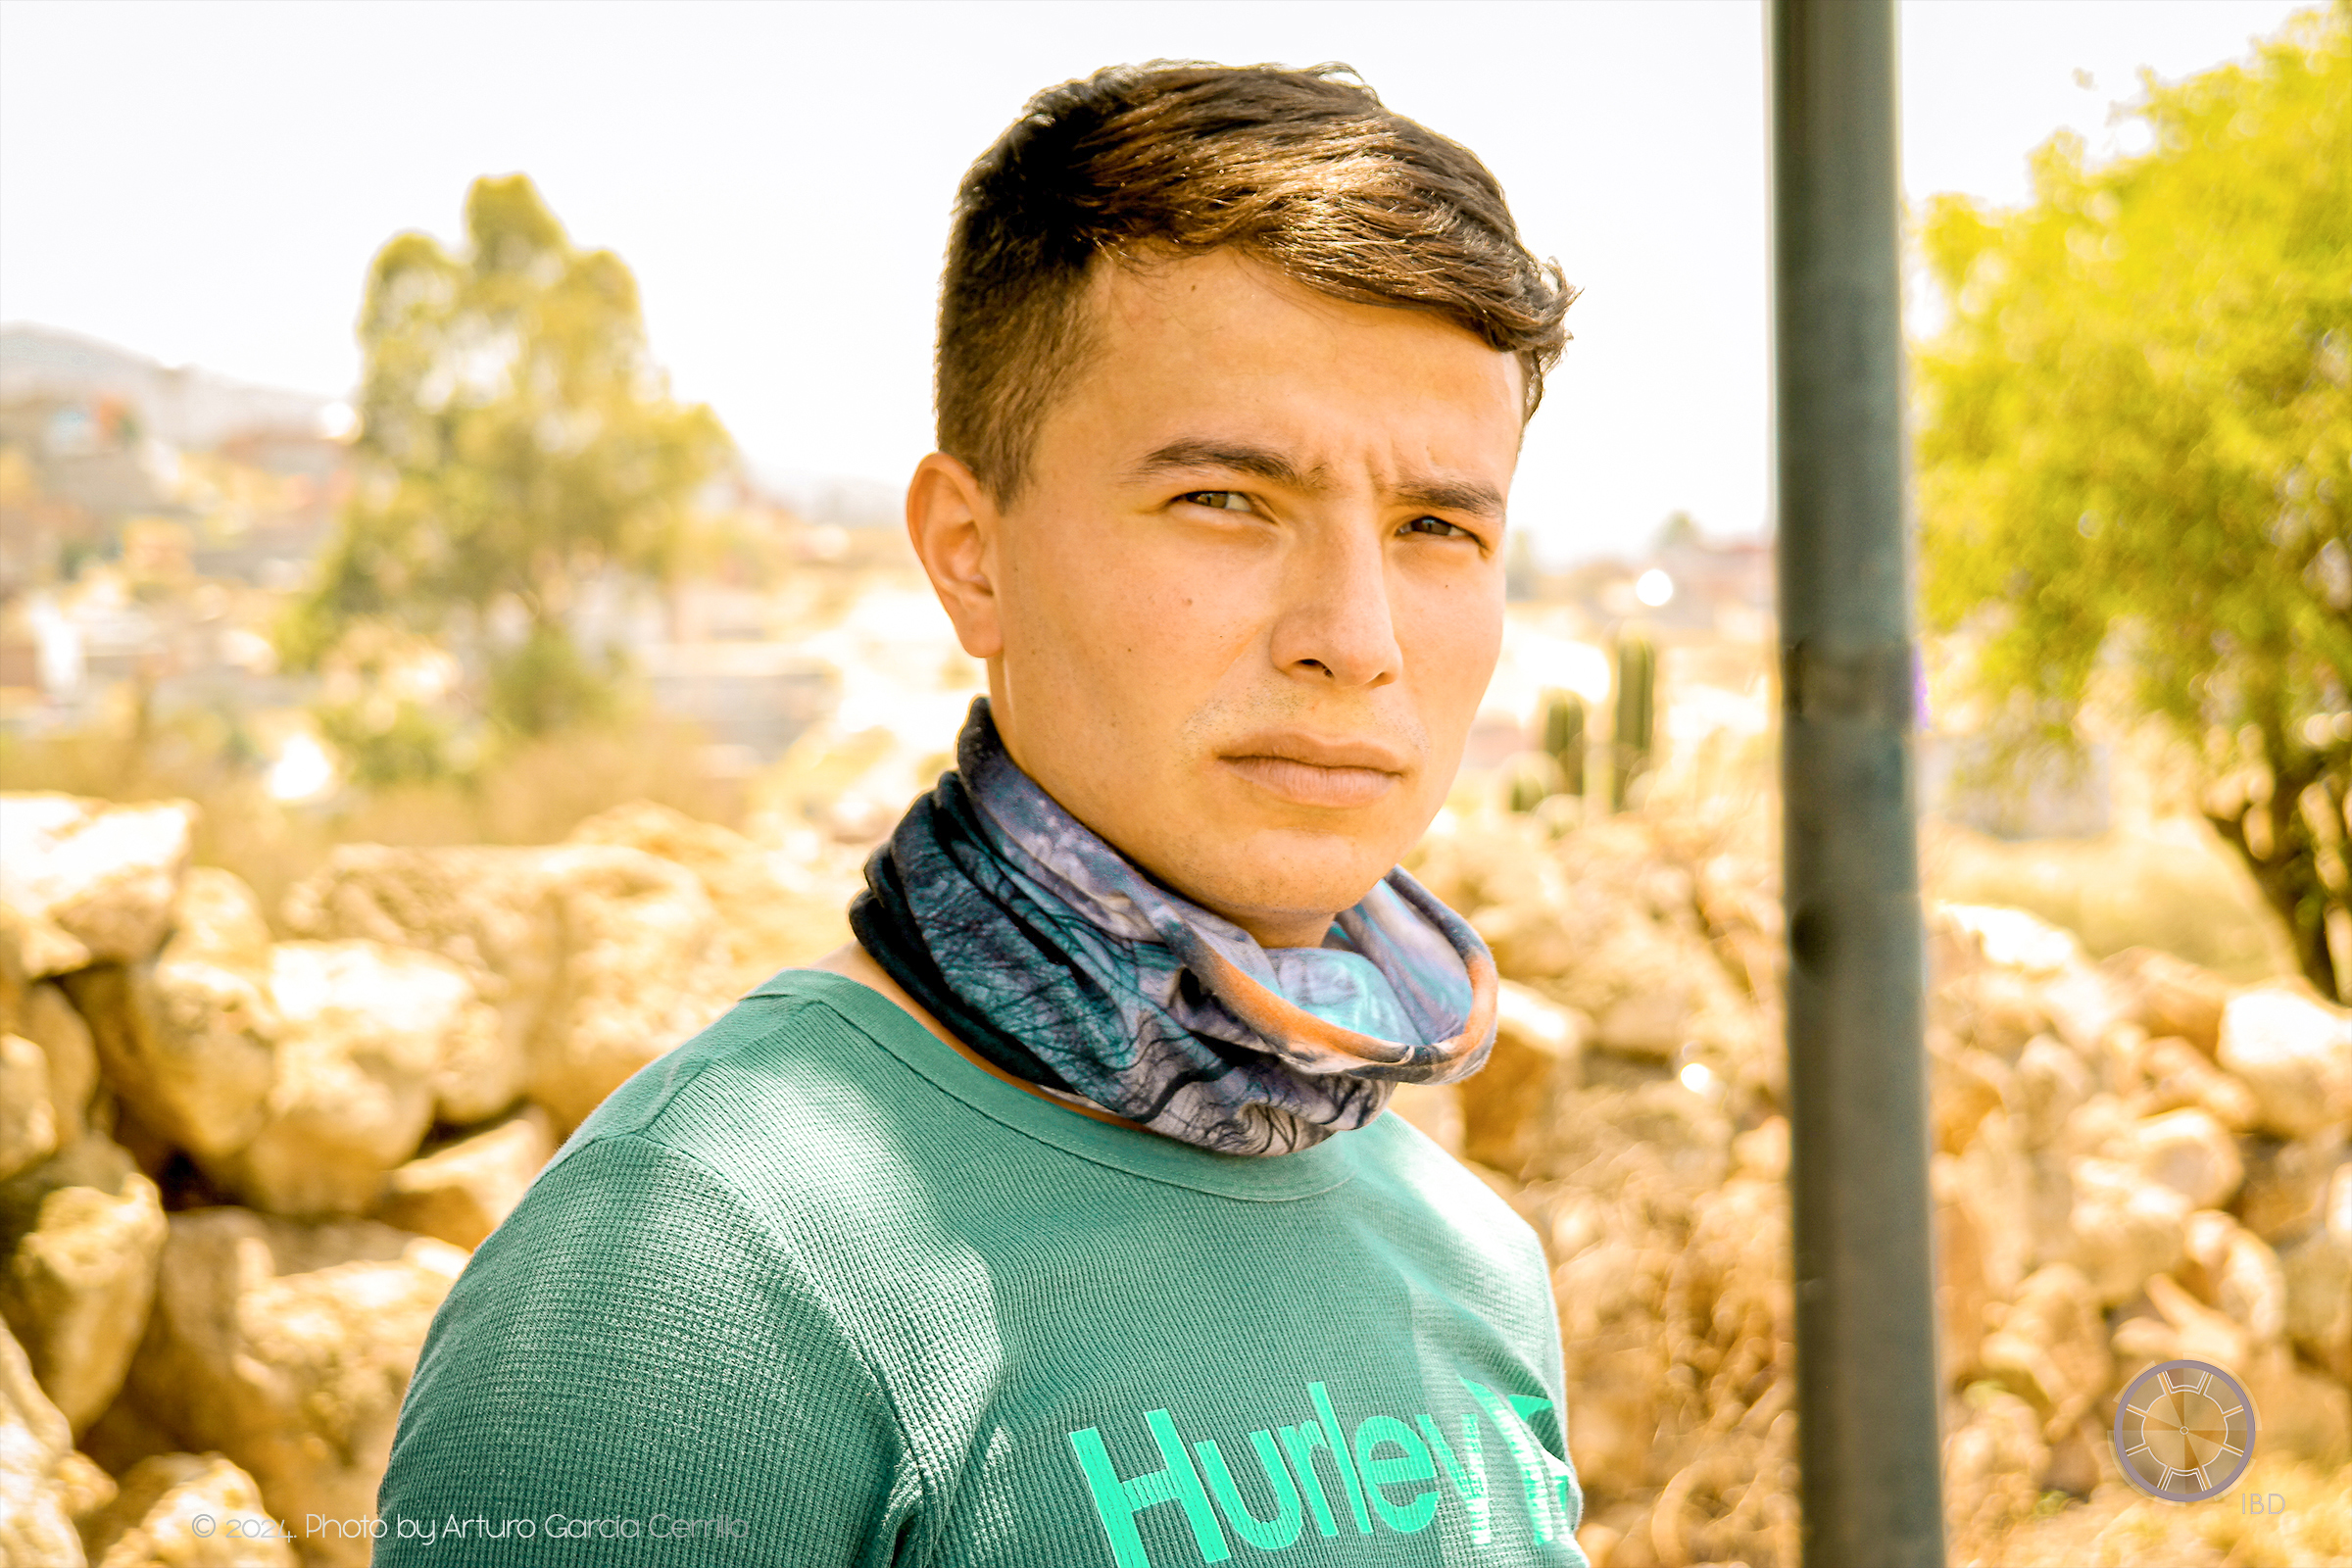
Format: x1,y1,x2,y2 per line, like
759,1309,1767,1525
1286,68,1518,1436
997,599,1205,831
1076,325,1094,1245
371,1133,922,1568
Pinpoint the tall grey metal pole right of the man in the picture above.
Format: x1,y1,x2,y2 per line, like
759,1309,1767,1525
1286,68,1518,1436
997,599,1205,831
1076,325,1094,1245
1769,0,1942,1568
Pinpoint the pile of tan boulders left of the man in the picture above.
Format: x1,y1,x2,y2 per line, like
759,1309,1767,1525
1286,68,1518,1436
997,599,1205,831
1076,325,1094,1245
0,795,840,1568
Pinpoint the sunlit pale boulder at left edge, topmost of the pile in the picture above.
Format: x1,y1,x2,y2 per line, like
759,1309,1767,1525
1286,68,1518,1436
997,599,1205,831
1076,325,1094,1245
0,795,195,980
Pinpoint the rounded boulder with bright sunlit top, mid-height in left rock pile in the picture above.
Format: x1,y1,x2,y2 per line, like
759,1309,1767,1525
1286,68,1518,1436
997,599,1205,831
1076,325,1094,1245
223,943,498,1218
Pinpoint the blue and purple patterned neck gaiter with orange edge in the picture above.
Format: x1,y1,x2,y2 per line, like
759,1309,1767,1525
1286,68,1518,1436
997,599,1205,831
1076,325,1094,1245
849,698,1495,1154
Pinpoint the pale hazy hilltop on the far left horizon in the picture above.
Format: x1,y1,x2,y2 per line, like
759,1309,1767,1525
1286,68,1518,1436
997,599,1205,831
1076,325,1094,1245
0,322,334,447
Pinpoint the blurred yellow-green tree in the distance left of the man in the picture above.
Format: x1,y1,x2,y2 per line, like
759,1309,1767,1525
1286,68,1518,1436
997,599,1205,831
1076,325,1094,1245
280,174,731,752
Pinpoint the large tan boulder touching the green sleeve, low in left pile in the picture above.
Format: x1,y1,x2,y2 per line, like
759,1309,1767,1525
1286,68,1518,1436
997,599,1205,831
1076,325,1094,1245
129,1208,466,1568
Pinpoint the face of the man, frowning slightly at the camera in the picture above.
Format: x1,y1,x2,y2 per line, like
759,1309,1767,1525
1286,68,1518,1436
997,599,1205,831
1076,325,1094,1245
910,252,1522,945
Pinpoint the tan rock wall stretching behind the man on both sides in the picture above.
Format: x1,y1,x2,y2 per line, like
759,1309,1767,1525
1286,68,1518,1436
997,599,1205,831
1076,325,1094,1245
0,795,2352,1568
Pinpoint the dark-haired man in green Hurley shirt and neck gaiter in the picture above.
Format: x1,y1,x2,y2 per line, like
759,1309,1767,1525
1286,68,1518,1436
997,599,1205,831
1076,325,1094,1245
376,66,1583,1568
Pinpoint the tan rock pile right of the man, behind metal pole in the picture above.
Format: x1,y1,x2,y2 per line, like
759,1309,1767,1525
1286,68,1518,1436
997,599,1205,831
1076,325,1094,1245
1404,813,2352,1568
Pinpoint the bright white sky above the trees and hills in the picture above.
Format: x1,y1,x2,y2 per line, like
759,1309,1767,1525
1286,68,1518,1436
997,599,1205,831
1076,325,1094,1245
0,0,2298,560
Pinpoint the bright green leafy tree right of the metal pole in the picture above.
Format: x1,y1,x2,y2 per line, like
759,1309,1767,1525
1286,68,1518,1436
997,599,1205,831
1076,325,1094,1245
1917,0,2352,999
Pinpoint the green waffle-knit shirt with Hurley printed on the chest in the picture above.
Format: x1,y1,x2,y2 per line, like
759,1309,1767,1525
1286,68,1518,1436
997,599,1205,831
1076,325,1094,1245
367,971,1586,1568
